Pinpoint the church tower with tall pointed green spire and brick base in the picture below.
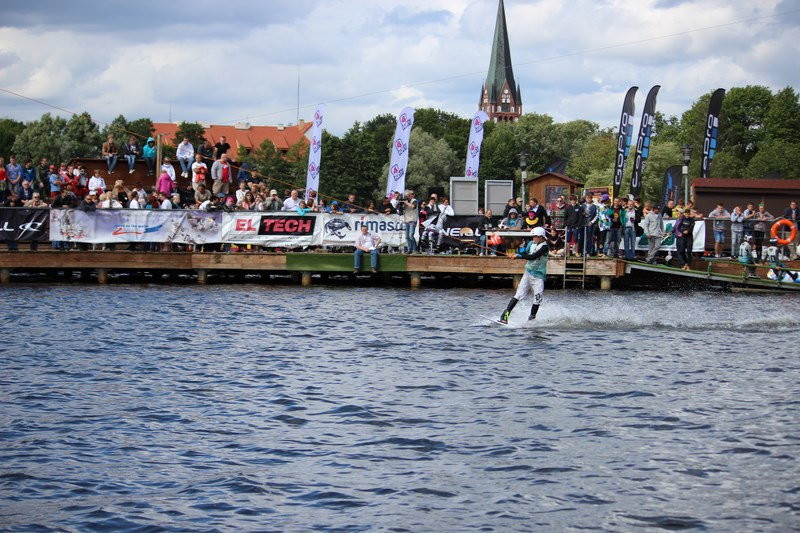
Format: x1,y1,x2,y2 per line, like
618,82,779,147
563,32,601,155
478,0,522,122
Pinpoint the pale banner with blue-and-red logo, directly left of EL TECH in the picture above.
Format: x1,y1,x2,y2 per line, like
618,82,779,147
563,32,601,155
50,209,223,244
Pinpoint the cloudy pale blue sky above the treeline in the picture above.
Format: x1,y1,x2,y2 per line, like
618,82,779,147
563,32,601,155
0,0,800,134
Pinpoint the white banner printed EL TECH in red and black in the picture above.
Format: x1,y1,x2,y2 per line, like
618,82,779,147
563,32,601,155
222,211,322,248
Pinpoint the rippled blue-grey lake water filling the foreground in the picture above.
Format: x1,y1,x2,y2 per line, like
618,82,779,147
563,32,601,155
0,285,800,531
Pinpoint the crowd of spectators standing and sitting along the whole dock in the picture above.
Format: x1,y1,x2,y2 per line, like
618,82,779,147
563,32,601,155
0,143,800,268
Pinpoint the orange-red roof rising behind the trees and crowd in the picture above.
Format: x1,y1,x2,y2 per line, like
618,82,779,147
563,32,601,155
153,120,311,159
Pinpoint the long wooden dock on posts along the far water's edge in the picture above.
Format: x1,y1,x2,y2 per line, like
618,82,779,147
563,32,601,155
0,250,800,291
